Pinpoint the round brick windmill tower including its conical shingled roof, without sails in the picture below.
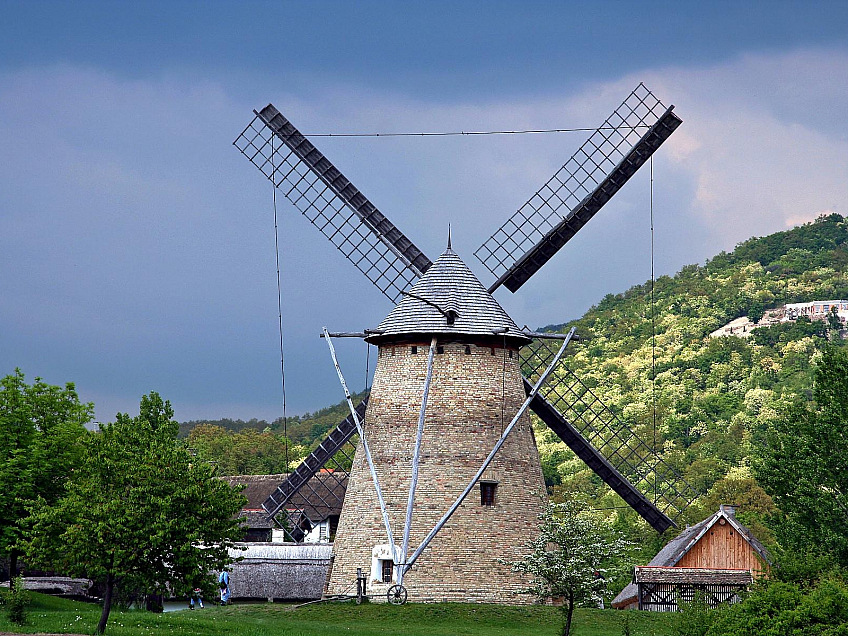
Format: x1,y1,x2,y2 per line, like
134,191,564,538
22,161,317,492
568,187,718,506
328,238,545,603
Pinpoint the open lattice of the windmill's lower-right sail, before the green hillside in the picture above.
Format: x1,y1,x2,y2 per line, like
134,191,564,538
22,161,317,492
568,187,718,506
519,340,701,521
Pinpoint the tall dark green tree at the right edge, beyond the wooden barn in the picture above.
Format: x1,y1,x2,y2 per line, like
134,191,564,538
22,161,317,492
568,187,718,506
755,349,848,566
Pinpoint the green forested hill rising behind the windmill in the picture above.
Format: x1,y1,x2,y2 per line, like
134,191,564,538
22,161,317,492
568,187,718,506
185,214,848,516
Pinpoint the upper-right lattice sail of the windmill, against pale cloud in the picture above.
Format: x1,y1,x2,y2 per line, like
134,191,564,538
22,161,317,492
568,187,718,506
474,83,680,291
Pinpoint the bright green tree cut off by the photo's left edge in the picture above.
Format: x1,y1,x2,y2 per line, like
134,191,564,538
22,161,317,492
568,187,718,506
0,369,93,587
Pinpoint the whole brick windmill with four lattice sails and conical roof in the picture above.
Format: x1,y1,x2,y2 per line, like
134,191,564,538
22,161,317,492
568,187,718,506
234,84,697,602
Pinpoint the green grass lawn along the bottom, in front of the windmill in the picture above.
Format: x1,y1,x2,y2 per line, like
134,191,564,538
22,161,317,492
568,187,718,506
0,594,677,636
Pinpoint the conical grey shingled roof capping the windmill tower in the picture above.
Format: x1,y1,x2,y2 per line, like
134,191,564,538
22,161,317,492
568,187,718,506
367,244,531,344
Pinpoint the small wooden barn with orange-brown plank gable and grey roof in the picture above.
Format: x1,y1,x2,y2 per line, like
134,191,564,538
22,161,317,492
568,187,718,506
612,505,770,612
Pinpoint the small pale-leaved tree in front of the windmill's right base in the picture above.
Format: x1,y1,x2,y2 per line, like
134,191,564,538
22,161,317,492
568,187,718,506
509,501,629,636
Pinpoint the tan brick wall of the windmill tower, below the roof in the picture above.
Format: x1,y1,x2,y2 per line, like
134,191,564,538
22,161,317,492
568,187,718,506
328,341,545,604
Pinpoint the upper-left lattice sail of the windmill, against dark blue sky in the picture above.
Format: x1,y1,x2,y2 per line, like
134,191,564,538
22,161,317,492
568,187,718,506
233,104,431,303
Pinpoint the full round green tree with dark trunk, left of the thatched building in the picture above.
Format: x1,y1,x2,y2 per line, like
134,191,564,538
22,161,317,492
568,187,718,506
24,392,245,634
